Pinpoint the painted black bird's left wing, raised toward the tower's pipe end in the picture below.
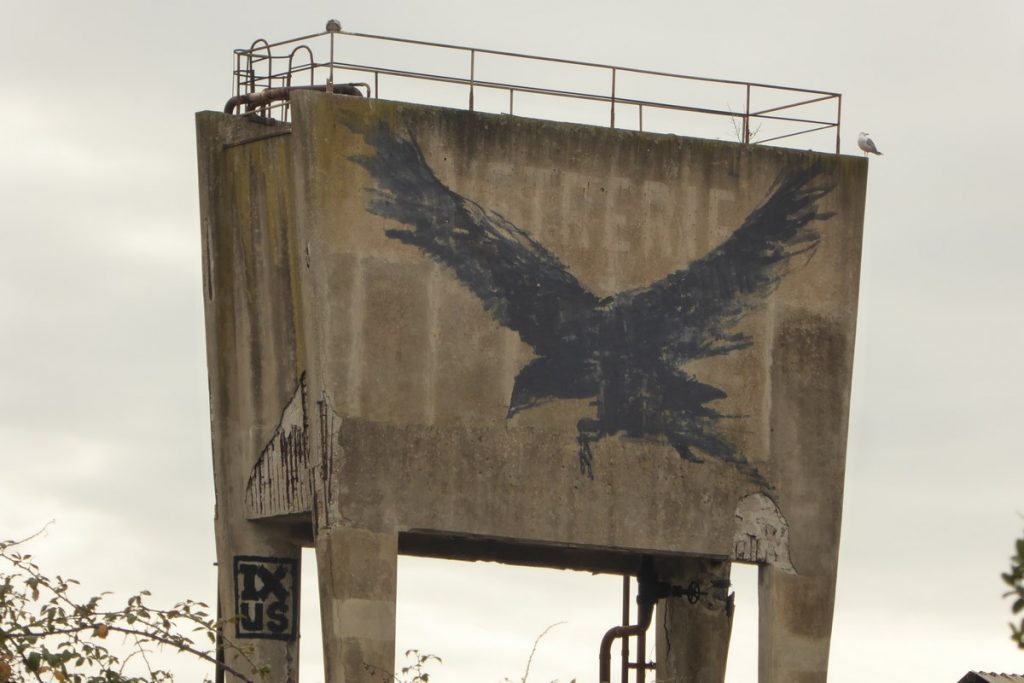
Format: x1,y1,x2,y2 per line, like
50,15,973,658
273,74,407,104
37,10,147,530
353,123,598,354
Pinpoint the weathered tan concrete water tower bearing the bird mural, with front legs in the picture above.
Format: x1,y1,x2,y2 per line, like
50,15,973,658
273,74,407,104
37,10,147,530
200,93,866,681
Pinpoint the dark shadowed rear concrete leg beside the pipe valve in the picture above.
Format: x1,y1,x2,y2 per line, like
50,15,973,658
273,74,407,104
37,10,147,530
655,559,732,683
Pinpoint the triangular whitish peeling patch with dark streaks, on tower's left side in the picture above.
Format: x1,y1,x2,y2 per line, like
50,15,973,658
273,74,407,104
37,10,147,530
246,375,312,519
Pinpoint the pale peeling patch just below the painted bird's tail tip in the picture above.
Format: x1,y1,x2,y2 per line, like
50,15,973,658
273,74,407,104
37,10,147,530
732,494,797,573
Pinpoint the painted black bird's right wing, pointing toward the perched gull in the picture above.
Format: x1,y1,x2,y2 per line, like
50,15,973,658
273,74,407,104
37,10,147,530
612,166,835,362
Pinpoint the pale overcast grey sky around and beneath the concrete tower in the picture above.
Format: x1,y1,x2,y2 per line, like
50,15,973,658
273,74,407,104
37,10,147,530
0,0,1024,683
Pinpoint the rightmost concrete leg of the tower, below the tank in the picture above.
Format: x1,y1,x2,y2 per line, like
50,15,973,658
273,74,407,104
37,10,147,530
758,565,836,683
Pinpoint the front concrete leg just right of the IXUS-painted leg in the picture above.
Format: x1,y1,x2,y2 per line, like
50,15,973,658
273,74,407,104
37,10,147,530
315,525,398,683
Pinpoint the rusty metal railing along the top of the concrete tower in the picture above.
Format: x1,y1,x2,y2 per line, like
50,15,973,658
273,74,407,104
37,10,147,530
225,20,842,154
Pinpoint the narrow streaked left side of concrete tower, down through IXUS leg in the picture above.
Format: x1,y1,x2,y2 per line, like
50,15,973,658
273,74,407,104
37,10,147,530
197,113,309,683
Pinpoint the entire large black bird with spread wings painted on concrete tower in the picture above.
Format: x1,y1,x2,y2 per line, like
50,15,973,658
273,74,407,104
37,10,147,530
347,122,834,487
